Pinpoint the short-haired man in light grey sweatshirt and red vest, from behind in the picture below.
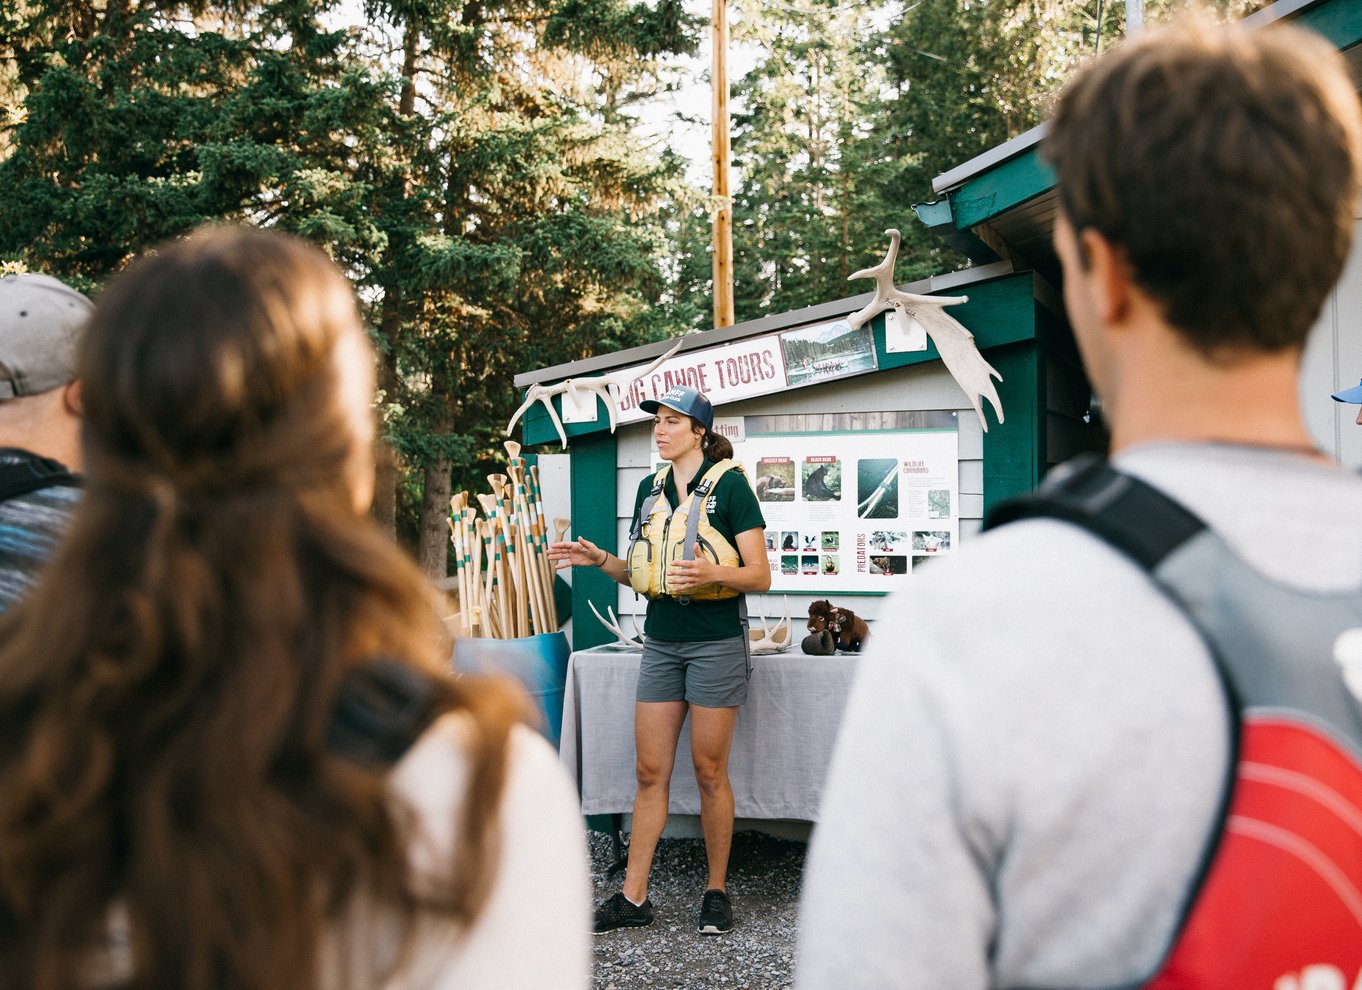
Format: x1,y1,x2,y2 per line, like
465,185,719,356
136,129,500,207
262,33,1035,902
797,19,1362,990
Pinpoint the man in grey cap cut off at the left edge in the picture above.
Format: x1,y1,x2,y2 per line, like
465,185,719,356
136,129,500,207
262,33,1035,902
0,274,94,611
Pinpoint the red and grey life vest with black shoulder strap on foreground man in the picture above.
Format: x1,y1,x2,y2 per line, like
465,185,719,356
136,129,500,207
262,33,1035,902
985,459,1362,990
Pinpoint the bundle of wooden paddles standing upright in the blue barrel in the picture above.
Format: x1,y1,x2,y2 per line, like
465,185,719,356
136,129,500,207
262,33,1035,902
449,440,568,639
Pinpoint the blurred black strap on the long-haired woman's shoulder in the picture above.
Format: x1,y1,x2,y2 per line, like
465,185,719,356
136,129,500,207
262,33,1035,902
327,659,436,767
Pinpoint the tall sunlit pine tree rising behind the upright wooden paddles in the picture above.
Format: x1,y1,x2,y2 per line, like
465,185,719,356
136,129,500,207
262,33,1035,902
345,0,695,575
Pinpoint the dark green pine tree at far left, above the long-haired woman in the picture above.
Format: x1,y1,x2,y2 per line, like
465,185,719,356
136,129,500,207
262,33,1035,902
0,1,385,289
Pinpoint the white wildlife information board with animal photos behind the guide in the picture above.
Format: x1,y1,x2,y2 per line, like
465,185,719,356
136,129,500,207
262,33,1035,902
734,429,960,595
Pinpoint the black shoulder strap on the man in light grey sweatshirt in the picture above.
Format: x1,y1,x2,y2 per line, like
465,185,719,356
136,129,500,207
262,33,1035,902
983,455,1205,571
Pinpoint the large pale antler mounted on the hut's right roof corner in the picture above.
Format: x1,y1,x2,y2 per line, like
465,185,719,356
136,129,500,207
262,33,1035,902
847,234,1002,433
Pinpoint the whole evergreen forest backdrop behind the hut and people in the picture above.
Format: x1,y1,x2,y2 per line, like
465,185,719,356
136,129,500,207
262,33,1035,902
0,0,1264,576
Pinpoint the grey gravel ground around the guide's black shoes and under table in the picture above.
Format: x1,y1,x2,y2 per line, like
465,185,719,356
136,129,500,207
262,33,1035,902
588,832,805,990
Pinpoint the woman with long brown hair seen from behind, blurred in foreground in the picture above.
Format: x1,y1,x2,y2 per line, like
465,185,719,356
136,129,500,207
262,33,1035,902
0,229,588,990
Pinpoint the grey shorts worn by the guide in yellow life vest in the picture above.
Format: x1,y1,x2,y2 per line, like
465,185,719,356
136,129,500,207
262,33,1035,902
637,635,752,708
